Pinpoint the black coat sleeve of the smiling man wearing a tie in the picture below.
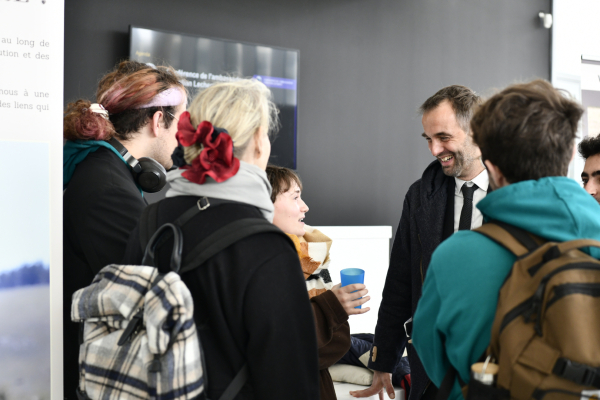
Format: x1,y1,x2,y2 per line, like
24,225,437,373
369,191,412,372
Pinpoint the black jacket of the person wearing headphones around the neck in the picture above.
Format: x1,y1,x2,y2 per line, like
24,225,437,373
63,148,146,400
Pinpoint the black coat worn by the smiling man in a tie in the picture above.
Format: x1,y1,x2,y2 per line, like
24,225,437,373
369,160,455,400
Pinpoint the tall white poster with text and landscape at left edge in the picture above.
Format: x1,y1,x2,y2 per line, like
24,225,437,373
0,0,64,400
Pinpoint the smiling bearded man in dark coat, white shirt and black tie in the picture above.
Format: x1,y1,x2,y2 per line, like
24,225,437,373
351,85,489,400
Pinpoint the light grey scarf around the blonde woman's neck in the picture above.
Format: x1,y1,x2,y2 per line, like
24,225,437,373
167,161,274,223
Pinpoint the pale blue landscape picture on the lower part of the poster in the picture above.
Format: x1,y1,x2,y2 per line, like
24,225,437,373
0,141,50,400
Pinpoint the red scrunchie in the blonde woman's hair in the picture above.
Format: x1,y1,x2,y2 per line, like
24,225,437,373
177,111,240,185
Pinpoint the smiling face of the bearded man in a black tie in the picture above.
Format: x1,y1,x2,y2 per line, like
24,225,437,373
421,100,483,180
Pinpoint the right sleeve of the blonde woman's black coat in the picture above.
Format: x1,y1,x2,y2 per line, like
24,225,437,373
243,249,319,400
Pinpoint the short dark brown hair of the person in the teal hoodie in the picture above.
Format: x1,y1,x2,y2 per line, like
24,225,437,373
471,79,583,183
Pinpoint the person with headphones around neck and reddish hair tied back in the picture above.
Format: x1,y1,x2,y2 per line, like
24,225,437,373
63,61,187,400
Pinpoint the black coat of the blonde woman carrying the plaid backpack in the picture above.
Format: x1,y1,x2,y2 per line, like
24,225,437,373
119,196,319,400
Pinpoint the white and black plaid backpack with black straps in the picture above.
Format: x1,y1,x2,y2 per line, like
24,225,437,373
71,197,284,400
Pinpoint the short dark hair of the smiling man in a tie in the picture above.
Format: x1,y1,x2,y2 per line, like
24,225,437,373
419,85,481,133
